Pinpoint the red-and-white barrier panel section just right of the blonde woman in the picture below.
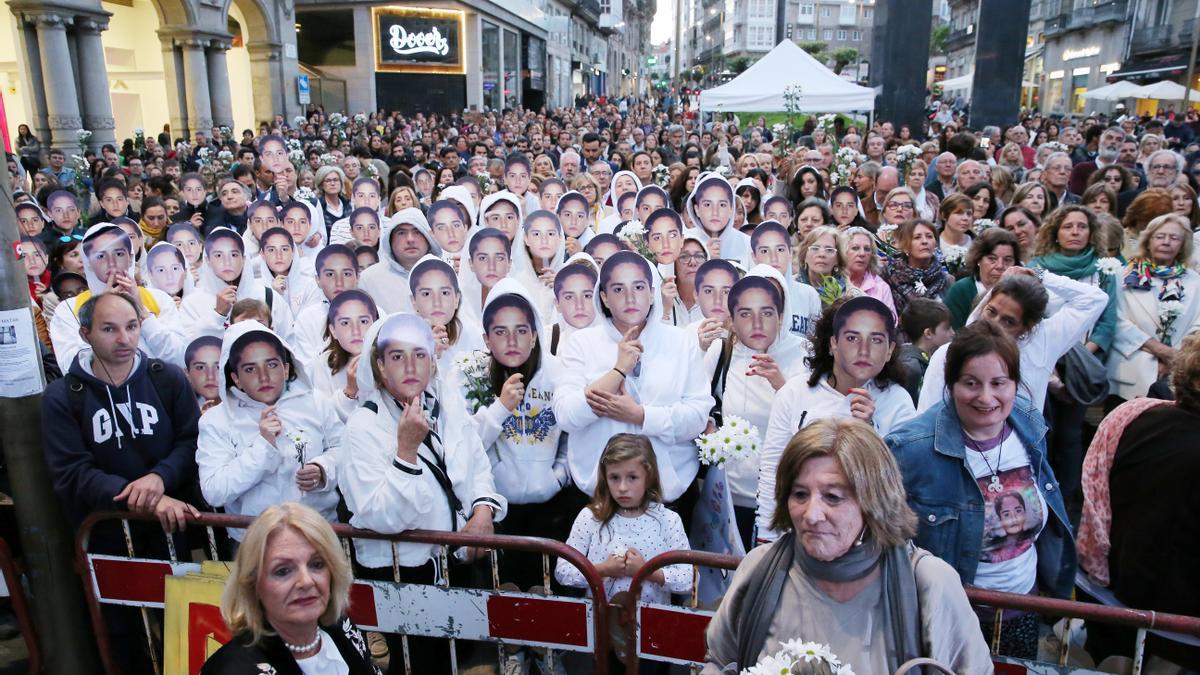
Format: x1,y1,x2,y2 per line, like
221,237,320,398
350,581,595,652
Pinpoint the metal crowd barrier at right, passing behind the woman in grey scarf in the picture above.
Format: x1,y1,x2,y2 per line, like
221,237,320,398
619,551,1200,675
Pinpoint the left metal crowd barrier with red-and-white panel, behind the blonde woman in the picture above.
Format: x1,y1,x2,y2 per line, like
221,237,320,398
76,513,608,675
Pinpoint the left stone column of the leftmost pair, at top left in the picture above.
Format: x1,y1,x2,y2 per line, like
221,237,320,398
34,13,83,154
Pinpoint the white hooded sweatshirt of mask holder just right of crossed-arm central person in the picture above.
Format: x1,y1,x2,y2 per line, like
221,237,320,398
704,264,811,508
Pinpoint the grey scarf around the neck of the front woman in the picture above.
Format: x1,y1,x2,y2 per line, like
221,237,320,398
738,532,924,671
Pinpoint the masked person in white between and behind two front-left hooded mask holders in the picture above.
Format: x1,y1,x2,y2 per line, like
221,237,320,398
308,288,379,422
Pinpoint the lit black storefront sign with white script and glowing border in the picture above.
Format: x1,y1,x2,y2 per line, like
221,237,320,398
371,6,463,73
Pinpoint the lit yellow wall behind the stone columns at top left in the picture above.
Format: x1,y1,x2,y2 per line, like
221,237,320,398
0,0,254,147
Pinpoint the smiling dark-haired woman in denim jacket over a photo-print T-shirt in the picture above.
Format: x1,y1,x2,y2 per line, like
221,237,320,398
887,321,1075,658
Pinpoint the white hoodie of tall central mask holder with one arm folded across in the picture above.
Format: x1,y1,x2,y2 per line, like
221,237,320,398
554,251,713,503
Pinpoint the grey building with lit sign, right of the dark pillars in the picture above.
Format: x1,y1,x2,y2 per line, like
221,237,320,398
1026,0,1132,114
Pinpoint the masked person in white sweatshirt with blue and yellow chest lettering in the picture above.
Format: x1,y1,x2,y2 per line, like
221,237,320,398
455,279,571,590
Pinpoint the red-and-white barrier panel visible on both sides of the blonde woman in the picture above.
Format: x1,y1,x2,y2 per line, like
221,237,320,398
88,554,595,656
